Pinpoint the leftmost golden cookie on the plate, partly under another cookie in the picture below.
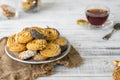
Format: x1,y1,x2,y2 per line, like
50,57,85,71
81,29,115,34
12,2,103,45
7,34,26,52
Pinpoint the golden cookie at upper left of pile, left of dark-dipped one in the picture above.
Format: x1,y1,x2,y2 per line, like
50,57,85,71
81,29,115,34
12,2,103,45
16,30,33,43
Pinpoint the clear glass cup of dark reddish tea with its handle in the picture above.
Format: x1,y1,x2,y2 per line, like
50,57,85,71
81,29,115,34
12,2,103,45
85,5,113,28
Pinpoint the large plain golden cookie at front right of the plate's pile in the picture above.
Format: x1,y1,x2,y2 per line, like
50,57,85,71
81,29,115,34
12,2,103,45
40,43,61,57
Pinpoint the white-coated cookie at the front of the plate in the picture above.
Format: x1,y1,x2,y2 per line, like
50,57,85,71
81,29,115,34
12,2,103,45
18,50,37,60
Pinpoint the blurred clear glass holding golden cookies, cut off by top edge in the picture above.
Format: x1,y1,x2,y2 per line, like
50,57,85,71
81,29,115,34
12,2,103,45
21,0,40,13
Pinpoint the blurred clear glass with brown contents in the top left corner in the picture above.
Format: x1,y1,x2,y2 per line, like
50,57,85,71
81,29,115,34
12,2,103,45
0,0,19,20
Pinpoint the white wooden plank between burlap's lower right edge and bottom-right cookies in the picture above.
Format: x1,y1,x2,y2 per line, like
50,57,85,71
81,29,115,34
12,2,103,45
49,56,117,77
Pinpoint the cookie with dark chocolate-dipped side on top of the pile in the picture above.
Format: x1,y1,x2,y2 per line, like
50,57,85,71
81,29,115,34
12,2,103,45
30,27,47,39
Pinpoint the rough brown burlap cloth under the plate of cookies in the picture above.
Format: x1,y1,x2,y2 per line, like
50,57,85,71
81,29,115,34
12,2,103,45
0,37,82,80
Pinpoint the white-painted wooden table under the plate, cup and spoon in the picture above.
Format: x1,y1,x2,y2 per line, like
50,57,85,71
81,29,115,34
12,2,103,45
0,0,120,80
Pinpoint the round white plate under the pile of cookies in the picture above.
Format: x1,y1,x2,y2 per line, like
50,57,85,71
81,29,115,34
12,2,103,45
5,42,71,64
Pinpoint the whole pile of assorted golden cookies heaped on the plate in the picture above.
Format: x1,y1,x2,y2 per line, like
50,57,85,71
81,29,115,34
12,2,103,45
7,26,67,60
